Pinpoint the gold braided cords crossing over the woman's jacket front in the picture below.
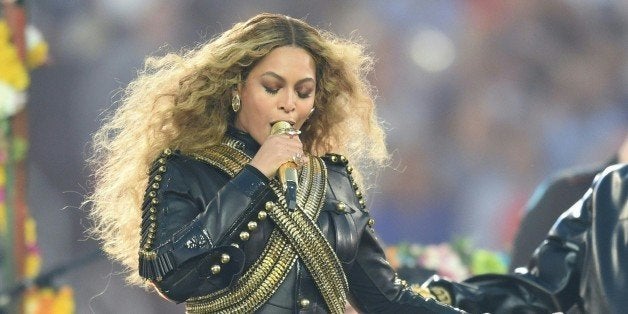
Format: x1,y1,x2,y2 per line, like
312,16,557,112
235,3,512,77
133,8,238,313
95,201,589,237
186,141,338,313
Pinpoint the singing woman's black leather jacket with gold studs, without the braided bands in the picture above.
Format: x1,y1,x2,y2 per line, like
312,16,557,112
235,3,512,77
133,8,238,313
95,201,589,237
140,128,458,313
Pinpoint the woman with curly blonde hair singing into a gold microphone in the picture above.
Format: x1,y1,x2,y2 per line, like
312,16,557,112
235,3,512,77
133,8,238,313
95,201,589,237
90,14,458,313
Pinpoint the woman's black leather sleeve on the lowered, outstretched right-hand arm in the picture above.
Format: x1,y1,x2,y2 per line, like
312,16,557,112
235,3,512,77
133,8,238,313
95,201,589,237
328,155,464,314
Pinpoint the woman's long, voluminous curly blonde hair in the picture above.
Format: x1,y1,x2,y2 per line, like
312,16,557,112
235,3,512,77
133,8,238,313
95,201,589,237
85,13,388,285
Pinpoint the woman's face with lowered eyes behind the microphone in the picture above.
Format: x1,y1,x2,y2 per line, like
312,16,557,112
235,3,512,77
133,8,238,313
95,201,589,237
235,46,316,144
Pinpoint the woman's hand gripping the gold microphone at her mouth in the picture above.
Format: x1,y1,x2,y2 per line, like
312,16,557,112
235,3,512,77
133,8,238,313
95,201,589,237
250,134,305,178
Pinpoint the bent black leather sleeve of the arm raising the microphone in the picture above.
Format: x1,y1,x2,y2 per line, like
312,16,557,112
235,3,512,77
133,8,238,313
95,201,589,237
139,151,270,302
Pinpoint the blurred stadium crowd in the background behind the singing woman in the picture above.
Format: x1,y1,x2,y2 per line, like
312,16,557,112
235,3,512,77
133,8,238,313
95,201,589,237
14,0,628,313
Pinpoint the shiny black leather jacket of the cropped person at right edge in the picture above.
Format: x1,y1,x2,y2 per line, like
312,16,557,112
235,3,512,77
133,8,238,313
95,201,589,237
426,164,628,313
